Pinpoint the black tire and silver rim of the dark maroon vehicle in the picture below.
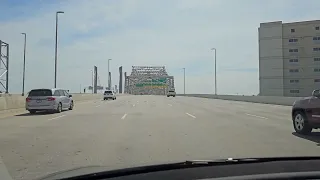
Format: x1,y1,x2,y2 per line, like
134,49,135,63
292,111,312,134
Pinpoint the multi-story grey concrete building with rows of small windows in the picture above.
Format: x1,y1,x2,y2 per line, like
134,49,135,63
259,20,320,96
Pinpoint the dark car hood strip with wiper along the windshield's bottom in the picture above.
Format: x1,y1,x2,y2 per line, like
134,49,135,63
38,156,320,180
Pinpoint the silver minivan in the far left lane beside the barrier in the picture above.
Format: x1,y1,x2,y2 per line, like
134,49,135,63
26,89,74,114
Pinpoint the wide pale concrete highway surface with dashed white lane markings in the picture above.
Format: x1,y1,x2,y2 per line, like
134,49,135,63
0,95,320,179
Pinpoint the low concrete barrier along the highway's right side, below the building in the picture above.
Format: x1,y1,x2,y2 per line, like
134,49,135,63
177,94,301,106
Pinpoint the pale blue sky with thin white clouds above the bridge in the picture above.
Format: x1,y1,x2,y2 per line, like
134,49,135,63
0,0,320,95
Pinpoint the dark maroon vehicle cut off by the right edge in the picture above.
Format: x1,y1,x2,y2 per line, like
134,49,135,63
292,89,320,134
